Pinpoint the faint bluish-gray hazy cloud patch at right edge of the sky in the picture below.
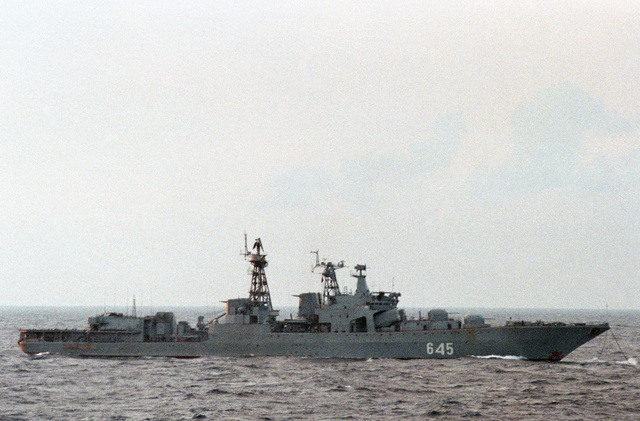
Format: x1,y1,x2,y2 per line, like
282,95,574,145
503,83,640,188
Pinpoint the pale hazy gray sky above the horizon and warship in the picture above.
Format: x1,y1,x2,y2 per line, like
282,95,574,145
0,1,640,309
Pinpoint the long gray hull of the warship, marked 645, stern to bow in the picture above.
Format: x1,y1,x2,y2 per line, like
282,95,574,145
20,324,609,361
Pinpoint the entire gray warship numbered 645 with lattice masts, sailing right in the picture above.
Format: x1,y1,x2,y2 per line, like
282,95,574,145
18,235,609,361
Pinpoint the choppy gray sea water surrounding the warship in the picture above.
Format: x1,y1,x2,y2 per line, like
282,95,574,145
0,307,640,420
